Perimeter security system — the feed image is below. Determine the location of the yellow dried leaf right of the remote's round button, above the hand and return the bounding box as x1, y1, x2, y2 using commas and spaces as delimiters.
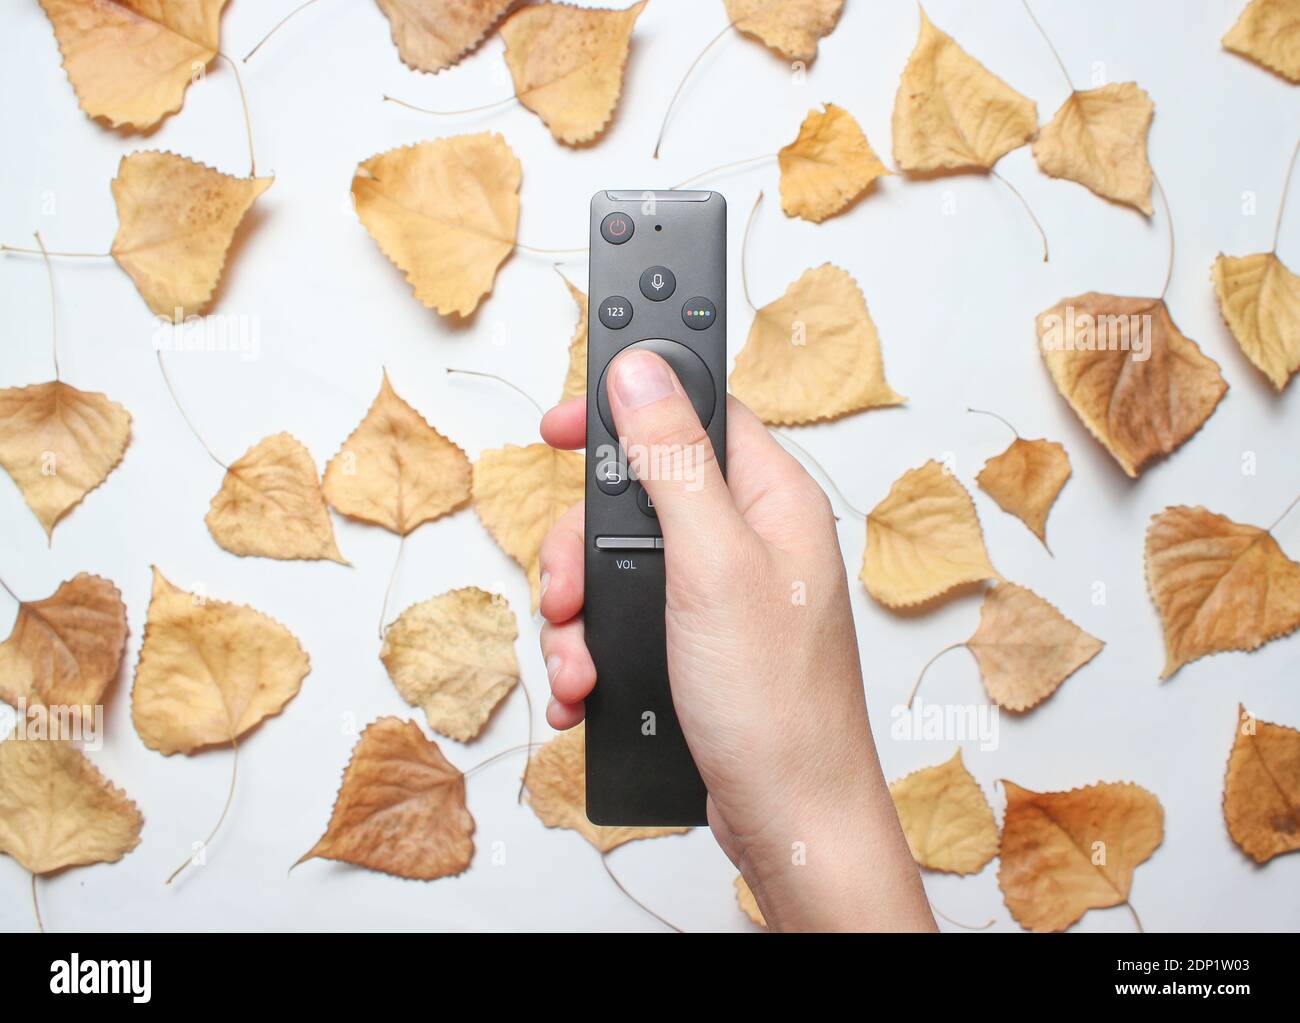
731, 263, 906, 425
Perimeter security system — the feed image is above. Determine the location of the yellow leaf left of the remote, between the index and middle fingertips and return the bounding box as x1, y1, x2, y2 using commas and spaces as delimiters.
473, 445, 585, 611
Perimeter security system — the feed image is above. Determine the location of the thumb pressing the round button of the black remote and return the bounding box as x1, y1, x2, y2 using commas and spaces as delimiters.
608, 348, 741, 550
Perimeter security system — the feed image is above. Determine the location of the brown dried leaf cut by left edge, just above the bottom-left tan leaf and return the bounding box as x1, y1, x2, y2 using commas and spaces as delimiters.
0, 572, 126, 707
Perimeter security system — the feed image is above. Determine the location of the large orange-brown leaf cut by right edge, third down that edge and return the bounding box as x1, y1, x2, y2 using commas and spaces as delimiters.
1147, 507, 1300, 679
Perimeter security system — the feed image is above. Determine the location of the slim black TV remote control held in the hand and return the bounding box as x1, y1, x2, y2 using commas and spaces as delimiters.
584, 191, 727, 827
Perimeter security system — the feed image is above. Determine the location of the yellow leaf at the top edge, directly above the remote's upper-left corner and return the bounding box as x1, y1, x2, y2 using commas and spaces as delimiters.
501, 0, 646, 146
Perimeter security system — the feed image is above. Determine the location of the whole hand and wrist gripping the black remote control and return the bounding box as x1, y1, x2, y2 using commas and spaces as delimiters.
541, 351, 935, 929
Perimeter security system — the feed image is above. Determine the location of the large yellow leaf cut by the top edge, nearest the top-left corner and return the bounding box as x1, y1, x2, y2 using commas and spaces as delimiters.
40, 0, 226, 129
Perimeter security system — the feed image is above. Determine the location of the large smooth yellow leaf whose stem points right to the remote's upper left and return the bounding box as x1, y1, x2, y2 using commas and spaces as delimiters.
352, 133, 521, 316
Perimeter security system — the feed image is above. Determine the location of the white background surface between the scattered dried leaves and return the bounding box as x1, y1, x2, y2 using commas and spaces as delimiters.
0, 0, 1300, 931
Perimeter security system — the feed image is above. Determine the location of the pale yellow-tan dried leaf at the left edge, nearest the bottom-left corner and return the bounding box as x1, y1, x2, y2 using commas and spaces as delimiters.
0, 737, 144, 874
